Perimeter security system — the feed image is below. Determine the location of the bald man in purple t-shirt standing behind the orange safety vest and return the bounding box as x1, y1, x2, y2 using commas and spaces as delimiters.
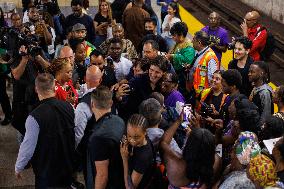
201, 12, 229, 62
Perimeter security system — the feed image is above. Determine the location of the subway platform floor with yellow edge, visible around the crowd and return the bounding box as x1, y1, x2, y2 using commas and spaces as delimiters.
0, 0, 284, 189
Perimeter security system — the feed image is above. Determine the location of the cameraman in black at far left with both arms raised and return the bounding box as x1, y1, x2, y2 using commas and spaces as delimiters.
11, 45, 49, 134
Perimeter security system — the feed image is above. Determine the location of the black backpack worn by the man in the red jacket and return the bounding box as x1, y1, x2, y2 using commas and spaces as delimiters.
256, 27, 275, 60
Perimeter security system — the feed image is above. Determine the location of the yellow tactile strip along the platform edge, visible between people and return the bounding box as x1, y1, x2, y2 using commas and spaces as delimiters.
179, 5, 277, 112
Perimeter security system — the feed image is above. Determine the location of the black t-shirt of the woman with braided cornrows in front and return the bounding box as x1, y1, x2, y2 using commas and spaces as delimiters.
128, 138, 154, 189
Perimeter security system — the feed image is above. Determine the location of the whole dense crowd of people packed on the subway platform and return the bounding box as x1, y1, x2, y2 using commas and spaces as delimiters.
0, 0, 284, 189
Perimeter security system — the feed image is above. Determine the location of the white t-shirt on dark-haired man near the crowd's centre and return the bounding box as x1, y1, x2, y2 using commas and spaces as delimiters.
113, 57, 132, 81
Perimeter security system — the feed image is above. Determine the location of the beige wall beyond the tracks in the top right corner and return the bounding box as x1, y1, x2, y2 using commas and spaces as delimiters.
241, 0, 284, 24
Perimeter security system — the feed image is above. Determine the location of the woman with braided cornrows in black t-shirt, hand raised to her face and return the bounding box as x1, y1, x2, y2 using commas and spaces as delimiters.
120, 114, 155, 189
